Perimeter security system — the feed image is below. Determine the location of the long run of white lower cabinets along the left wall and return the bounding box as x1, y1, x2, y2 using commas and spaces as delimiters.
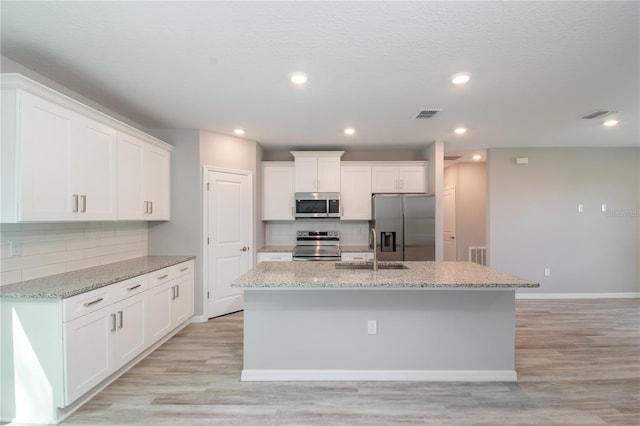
0, 260, 194, 424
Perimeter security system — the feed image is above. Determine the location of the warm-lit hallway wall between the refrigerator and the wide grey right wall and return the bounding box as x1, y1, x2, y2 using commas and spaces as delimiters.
444, 163, 487, 260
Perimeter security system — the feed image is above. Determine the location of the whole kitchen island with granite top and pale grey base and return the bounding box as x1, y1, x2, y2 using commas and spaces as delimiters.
232, 262, 539, 381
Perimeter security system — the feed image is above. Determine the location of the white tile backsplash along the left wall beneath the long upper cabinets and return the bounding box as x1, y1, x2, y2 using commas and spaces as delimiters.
0, 222, 148, 285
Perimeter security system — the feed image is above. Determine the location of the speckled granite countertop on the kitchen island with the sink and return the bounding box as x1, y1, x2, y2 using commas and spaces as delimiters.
231, 262, 540, 290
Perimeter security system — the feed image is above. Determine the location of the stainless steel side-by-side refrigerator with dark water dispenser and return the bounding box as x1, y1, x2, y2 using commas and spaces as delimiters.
371, 194, 436, 261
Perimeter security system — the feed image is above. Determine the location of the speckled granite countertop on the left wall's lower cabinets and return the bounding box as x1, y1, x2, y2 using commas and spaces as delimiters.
0, 256, 195, 299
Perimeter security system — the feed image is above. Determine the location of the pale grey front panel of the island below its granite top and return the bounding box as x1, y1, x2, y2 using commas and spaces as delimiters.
243, 288, 515, 380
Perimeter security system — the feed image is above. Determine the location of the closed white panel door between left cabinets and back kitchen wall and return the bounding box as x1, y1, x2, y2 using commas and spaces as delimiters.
205, 168, 253, 318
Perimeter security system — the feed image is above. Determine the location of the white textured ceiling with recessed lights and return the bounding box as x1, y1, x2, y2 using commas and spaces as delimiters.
0, 0, 640, 155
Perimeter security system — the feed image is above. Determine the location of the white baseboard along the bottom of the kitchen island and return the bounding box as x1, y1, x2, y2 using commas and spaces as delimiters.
240, 370, 518, 382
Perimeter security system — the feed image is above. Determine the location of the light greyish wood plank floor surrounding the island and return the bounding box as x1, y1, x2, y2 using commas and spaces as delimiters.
63, 299, 640, 425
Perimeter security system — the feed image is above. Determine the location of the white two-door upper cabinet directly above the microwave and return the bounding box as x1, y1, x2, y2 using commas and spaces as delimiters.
291, 151, 344, 192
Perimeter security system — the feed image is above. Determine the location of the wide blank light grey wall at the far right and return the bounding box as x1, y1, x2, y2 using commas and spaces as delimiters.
487, 148, 640, 293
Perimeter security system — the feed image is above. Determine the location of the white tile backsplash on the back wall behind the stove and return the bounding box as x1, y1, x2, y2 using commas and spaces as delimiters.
265, 219, 369, 246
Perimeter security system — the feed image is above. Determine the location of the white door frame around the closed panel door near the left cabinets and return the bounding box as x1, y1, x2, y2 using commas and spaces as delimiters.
202, 165, 256, 321
